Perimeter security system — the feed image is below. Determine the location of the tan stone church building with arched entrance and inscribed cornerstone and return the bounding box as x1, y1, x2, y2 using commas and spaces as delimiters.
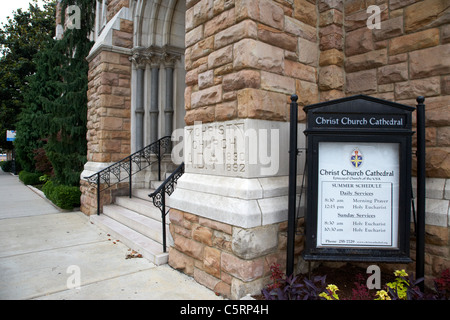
59, 0, 450, 299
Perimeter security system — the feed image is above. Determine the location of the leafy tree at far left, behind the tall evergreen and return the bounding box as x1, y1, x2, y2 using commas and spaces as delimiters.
0, 0, 56, 151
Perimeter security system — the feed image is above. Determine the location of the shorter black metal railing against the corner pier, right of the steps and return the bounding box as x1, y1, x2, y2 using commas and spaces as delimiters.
148, 162, 184, 252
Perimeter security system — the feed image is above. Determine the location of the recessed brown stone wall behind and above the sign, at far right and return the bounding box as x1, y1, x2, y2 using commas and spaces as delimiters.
344, 0, 450, 178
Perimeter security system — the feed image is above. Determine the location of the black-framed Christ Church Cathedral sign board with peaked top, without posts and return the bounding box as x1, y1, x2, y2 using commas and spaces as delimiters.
304, 95, 414, 262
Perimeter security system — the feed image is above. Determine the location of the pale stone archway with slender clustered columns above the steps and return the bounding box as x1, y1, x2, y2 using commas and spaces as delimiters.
131, 0, 186, 150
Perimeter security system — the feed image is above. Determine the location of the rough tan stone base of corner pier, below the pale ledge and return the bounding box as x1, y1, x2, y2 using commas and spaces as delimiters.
169, 209, 302, 299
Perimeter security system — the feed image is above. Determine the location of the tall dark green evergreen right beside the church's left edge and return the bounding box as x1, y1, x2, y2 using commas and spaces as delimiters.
16, 0, 95, 186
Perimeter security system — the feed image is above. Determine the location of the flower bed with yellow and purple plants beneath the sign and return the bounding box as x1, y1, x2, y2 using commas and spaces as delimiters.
255, 264, 450, 300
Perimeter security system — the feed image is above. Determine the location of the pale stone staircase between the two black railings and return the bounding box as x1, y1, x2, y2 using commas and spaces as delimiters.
90, 181, 173, 265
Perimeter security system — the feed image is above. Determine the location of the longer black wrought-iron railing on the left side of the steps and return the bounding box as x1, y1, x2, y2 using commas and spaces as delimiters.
85, 136, 172, 214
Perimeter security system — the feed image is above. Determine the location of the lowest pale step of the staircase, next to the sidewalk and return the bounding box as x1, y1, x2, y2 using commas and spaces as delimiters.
90, 214, 169, 265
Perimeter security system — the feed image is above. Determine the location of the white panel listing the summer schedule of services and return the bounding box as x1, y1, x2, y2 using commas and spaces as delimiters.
317, 142, 400, 248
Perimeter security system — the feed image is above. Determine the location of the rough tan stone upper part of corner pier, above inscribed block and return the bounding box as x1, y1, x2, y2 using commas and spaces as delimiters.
185, 0, 318, 125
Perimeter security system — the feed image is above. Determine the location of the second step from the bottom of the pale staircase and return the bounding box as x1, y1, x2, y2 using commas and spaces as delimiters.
103, 204, 173, 245
